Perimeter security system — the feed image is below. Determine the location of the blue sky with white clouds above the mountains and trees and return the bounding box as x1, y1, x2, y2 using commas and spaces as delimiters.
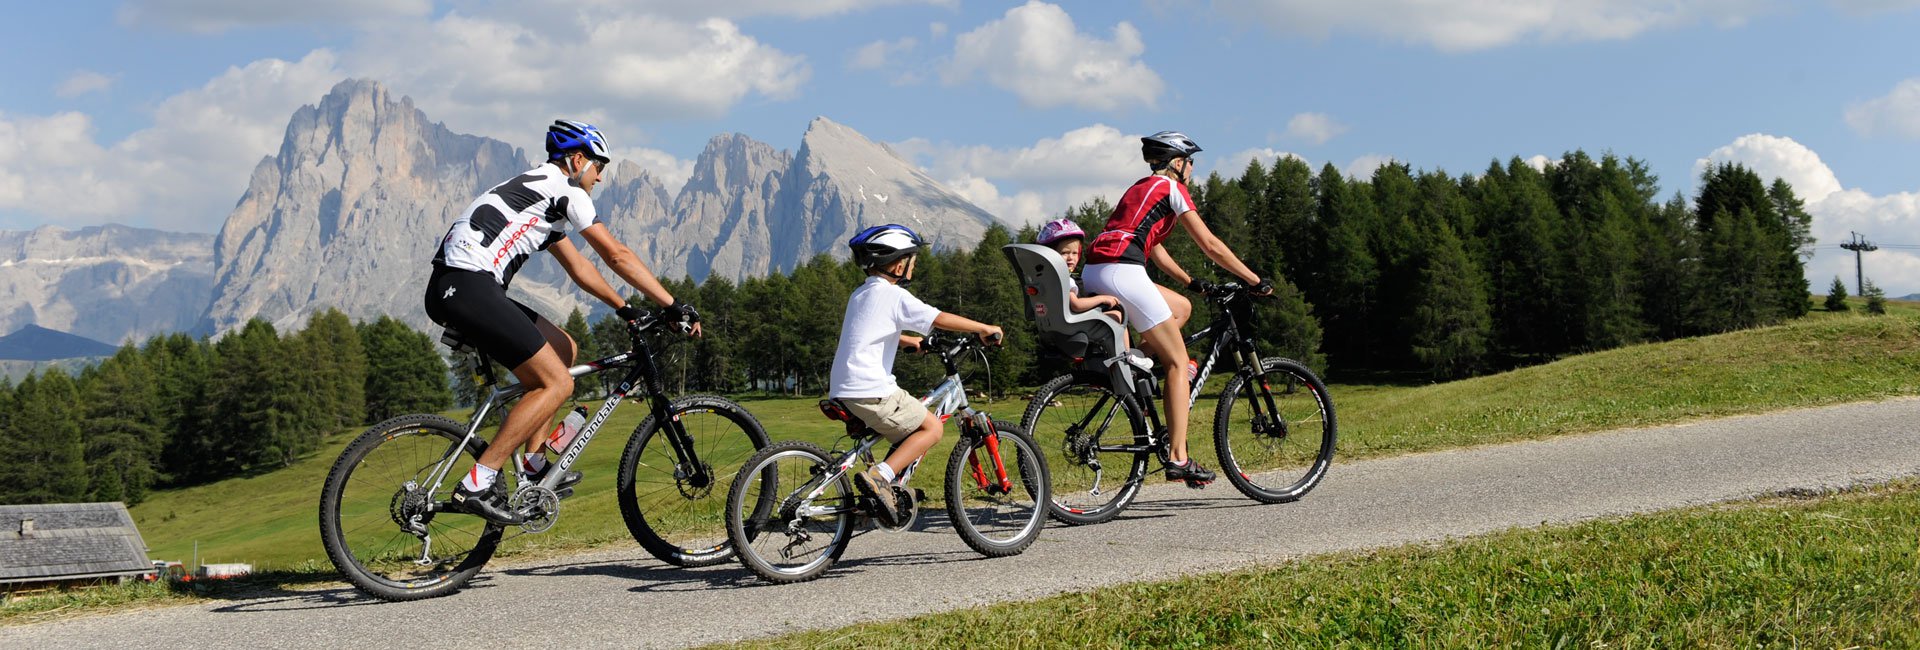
0, 0, 1920, 295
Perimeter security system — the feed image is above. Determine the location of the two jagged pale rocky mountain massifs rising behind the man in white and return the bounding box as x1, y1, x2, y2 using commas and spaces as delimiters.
194, 81, 995, 334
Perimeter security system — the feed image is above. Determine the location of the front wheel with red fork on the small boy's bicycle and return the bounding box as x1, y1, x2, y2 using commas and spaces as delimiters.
947, 422, 1048, 558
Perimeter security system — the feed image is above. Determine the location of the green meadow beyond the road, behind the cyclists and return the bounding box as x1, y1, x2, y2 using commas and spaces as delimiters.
132, 303, 1920, 569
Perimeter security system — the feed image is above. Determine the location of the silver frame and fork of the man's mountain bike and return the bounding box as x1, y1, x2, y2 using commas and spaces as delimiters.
426, 324, 714, 510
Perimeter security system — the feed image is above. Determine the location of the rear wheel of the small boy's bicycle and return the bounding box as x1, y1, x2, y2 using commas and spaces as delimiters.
726, 441, 854, 583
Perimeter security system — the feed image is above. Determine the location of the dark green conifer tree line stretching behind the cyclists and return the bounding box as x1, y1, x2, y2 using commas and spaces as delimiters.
0, 151, 1812, 502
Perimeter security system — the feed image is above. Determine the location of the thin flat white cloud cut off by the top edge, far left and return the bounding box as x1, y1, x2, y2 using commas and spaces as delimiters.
117, 0, 434, 33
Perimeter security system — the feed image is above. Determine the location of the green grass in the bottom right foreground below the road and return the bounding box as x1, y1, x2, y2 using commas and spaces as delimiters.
721, 481, 1920, 648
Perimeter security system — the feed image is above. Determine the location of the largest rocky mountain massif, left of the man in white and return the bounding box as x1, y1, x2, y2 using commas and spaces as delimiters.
205, 81, 530, 332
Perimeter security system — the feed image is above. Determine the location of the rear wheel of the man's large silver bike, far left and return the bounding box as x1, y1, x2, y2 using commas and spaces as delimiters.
321, 414, 501, 600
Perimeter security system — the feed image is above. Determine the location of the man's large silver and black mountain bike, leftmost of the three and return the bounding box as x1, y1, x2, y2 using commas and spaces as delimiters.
321, 314, 766, 600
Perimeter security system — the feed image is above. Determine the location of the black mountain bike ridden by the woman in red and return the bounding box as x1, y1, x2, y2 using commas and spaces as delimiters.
1008, 245, 1336, 523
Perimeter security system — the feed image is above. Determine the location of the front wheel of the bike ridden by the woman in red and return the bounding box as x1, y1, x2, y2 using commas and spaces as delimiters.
1213, 357, 1338, 502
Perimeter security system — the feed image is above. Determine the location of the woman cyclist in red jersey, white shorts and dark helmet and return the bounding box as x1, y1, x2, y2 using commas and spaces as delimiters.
1081, 130, 1273, 487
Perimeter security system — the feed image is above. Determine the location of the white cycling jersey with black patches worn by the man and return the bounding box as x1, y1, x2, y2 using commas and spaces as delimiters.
434, 163, 599, 286
